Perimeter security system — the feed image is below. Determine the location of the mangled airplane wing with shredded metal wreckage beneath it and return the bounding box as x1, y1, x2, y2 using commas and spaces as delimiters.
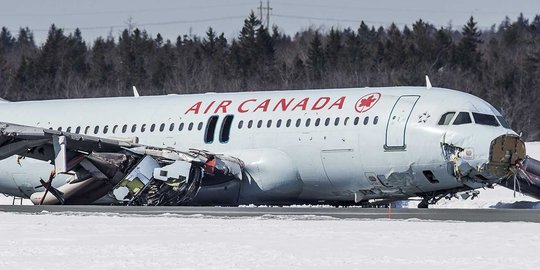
0, 122, 244, 205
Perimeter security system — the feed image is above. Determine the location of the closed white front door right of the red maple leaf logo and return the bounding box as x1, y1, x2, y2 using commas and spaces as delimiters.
384, 95, 420, 150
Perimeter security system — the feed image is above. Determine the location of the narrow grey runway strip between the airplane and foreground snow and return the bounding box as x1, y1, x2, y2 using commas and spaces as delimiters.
0, 205, 540, 223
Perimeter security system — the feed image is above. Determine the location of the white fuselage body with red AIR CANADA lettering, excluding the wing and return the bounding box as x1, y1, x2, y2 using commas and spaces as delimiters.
0, 87, 515, 204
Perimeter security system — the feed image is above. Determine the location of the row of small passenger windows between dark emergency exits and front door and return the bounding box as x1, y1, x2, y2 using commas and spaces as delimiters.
238, 116, 379, 129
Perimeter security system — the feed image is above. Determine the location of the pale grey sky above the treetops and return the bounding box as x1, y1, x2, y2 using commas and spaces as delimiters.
0, 0, 540, 43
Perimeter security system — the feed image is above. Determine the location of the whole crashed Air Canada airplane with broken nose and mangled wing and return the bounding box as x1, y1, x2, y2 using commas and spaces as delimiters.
0, 83, 540, 207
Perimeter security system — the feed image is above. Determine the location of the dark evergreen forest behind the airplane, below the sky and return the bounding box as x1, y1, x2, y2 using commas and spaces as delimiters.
0, 13, 540, 140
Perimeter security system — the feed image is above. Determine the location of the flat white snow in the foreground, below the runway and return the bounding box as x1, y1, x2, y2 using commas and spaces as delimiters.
0, 213, 540, 270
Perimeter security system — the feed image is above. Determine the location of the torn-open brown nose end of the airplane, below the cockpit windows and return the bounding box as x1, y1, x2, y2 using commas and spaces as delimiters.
486, 134, 525, 177
